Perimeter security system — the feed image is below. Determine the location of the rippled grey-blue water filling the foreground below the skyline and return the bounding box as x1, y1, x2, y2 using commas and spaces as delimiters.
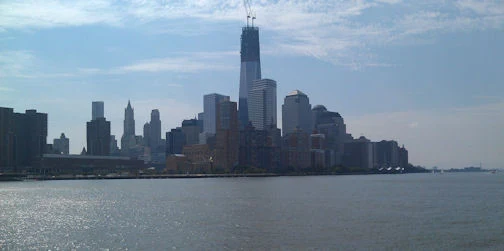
0, 173, 504, 250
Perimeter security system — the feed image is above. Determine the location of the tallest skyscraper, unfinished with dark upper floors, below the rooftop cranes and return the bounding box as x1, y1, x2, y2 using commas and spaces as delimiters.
239, 25, 261, 127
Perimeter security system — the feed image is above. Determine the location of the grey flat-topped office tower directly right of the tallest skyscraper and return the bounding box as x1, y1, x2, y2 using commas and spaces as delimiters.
248, 79, 277, 130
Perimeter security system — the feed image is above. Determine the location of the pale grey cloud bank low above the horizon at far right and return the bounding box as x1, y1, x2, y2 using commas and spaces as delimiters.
345, 102, 504, 168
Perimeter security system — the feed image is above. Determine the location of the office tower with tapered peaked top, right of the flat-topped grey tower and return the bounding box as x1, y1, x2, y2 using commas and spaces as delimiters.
282, 90, 312, 136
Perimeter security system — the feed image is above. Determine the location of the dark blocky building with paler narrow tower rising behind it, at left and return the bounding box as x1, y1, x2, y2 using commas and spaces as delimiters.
86, 118, 110, 156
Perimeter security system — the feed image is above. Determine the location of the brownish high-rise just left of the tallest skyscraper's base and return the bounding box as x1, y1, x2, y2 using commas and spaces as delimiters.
215, 101, 239, 170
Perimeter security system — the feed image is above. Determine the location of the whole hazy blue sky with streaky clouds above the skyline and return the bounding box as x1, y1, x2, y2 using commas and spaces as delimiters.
0, 0, 504, 168
